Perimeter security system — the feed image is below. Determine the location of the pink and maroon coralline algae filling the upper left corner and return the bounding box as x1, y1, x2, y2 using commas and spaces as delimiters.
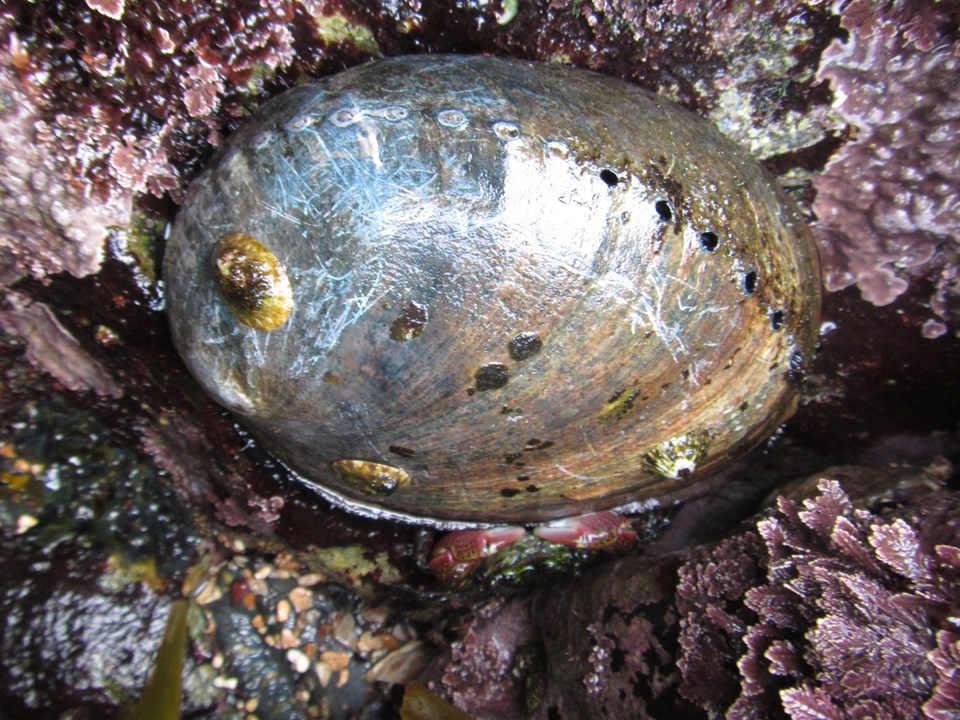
0, 0, 308, 284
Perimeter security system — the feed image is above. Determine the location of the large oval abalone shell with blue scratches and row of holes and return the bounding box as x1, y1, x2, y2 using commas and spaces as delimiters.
164, 56, 820, 525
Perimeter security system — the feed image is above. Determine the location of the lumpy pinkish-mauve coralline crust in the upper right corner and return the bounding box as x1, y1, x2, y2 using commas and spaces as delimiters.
813, 2, 960, 337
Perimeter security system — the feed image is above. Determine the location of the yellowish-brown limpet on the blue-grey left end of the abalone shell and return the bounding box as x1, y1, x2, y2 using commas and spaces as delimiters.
212, 233, 293, 330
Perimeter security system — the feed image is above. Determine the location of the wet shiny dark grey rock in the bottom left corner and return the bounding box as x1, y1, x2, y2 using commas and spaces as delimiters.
0, 537, 169, 718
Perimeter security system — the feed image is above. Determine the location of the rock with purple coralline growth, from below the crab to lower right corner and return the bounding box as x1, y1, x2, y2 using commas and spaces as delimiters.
438, 471, 960, 720
